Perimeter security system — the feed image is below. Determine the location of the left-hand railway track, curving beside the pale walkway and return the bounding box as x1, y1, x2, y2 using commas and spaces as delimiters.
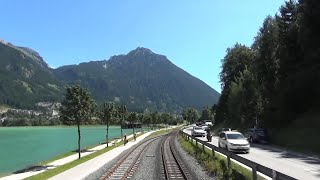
100, 137, 159, 180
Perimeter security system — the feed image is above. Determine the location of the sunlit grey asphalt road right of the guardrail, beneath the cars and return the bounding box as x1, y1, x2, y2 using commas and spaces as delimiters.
184, 128, 320, 180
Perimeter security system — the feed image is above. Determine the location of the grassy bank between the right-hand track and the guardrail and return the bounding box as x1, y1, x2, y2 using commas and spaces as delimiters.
178, 136, 264, 180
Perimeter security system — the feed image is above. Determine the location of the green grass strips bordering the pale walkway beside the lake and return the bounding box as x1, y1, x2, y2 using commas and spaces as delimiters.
26, 131, 142, 180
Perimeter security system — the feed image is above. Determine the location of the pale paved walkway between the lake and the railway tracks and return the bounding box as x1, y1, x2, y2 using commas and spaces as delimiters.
0, 131, 154, 180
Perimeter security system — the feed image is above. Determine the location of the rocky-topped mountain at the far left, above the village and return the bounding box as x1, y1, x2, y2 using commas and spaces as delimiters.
0, 41, 64, 108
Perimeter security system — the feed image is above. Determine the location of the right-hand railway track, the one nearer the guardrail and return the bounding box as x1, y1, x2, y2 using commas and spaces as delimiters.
161, 133, 191, 180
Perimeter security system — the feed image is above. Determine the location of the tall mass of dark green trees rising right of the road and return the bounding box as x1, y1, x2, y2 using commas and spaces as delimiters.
216, 0, 320, 155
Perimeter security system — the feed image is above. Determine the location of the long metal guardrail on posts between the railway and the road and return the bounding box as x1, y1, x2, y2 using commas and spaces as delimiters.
179, 130, 296, 180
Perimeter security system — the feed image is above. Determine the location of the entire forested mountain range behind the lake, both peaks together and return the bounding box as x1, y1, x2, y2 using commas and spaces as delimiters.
0, 42, 219, 112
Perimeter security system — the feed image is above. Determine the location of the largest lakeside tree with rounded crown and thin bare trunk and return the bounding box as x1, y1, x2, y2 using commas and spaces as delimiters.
60, 86, 96, 159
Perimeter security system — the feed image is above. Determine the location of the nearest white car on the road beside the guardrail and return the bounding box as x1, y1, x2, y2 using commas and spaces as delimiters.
218, 131, 250, 153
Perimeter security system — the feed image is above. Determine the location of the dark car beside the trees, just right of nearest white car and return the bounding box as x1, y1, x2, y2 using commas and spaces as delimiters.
244, 128, 269, 143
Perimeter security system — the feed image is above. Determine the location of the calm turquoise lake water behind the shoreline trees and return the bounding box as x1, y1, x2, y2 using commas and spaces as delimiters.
0, 126, 139, 174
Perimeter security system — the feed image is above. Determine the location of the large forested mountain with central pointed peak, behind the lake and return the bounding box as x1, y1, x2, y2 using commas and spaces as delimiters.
54, 48, 220, 112
